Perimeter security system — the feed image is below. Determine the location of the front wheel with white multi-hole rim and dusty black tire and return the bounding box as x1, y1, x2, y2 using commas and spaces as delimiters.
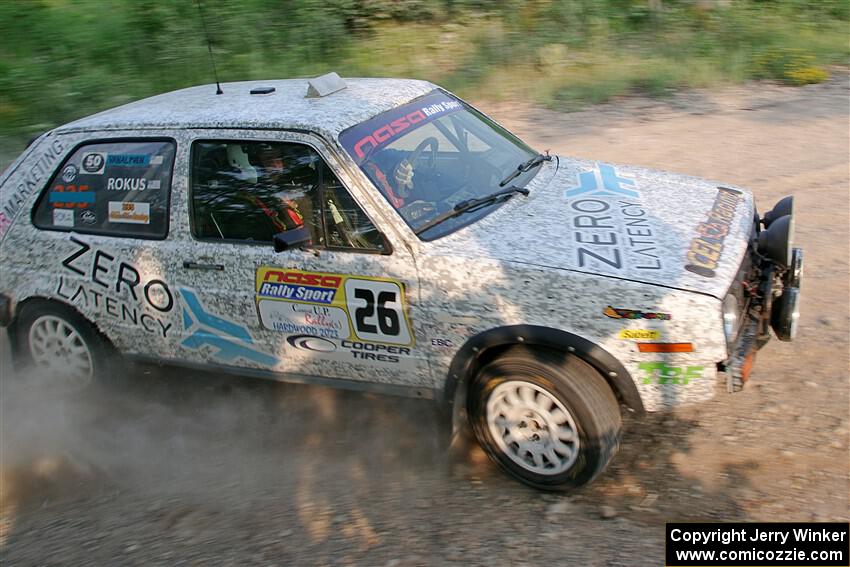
469, 347, 621, 490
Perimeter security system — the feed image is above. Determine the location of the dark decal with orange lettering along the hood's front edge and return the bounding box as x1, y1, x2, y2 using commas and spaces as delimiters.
685, 187, 742, 278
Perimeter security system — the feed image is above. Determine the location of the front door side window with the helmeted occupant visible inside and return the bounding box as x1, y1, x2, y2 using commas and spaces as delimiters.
191, 140, 385, 252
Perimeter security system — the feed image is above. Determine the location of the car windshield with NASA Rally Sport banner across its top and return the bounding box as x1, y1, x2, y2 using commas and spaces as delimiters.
339, 90, 539, 240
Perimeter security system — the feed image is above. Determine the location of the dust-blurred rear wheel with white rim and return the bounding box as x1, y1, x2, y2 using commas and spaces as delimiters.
16, 303, 110, 389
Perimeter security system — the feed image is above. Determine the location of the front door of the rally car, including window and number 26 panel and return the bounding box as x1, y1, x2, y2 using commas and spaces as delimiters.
172, 131, 430, 389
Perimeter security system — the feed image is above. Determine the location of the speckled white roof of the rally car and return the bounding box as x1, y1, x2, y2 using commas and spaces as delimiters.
56, 78, 436, 139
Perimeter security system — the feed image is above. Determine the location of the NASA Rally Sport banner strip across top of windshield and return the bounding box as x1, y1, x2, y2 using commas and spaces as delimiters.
339, 91, 463, 165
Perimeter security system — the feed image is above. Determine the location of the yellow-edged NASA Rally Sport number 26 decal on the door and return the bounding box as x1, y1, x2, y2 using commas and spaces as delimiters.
256, 267, 414, 345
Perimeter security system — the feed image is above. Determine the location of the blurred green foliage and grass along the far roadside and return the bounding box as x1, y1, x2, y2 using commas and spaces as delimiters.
0, 0, 850, 145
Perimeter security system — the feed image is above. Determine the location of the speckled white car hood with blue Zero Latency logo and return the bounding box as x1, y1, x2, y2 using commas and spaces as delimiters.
430, 156, 754, 298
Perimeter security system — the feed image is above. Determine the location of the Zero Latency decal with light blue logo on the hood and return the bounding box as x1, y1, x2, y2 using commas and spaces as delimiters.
564, 163, 662, 271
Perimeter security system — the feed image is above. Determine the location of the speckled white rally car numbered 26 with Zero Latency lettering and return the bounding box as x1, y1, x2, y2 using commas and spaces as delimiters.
0, 74, 802, 489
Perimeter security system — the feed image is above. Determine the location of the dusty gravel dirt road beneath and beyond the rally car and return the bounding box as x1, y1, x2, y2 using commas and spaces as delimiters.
0, 73, 850, 566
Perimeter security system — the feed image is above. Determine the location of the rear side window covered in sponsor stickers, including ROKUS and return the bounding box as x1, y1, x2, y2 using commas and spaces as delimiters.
33, 140, 174, 242
